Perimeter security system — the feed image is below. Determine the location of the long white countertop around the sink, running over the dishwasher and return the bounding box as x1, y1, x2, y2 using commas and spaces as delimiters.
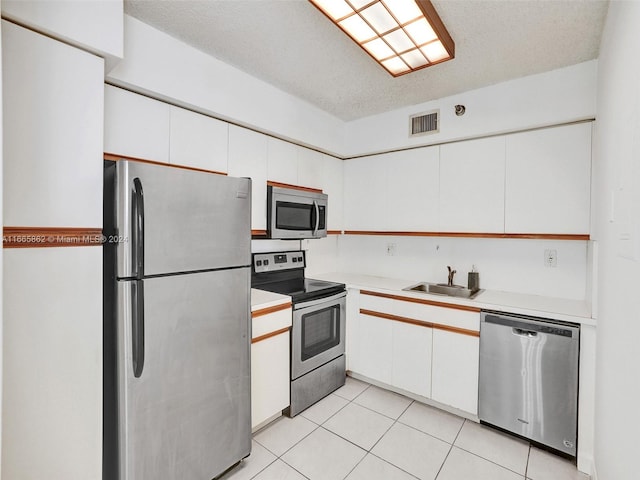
313, 272, 596, 326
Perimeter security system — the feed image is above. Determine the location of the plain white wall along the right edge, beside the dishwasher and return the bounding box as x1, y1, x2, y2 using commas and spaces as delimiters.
594, 1, 640, 480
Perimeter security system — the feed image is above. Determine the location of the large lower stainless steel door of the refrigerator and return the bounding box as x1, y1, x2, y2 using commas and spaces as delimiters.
117, 268, 251, 480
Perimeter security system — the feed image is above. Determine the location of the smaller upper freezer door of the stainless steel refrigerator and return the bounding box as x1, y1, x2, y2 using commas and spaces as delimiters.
114, 160, 251, 278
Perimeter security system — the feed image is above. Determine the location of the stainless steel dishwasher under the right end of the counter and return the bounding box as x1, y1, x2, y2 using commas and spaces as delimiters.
478, 312, 580, 457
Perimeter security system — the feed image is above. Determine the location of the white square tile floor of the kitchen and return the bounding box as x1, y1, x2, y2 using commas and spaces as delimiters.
223, 377, 589, 480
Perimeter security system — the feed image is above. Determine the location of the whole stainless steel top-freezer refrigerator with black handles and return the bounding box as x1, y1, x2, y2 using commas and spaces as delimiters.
103, 160, 251, 480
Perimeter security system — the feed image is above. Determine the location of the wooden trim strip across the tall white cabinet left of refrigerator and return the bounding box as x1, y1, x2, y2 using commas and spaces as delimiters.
2, 226, 102, 248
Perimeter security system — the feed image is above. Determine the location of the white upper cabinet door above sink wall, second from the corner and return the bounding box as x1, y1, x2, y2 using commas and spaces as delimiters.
382, 147, 440, 232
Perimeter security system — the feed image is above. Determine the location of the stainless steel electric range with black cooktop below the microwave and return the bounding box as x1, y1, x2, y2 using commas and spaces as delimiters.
251, 250, 347, 417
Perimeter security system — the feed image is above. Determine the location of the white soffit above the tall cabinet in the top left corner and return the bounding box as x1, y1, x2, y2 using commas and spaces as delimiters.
2, 0, 124, 62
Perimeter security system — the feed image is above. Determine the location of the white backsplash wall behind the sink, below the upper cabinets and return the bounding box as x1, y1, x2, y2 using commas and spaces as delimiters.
303, 235, 590, 300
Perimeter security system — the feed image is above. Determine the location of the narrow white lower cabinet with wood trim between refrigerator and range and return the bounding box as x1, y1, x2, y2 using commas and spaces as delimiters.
251, 306, 292, 430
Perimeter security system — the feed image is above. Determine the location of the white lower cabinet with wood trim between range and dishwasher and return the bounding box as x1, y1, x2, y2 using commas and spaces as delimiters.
347, 290, 480, 416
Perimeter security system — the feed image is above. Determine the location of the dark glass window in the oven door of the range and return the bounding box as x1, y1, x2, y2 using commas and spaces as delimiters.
302, 305, 340, 361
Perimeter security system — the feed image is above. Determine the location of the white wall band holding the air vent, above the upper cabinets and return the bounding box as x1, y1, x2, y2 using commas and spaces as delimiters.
343, 60, 597, 157
